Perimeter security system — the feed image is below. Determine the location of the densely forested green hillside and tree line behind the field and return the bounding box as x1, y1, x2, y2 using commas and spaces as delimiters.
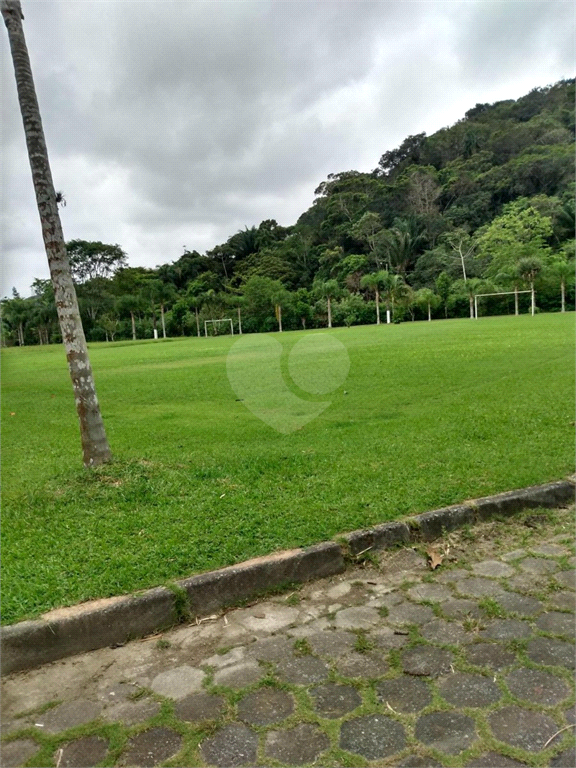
2, 80, 574, 344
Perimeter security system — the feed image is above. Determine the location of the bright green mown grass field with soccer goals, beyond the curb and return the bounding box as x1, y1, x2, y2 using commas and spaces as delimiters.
2, 313, 574, 623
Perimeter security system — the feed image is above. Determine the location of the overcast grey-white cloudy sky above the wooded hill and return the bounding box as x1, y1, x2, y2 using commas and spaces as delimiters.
1, 0, 574, 295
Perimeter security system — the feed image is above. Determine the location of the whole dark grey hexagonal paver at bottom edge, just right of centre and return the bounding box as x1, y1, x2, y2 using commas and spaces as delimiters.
340, 715, 406, 760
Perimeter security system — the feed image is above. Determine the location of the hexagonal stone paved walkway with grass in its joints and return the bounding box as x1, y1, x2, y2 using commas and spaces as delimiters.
2, 509, 576, 768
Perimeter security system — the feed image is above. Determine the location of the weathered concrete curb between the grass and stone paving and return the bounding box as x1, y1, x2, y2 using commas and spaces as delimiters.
0, 480, 575, 675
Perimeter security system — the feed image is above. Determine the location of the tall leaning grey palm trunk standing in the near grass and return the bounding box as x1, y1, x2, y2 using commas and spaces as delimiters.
1, 0, 112, 466
